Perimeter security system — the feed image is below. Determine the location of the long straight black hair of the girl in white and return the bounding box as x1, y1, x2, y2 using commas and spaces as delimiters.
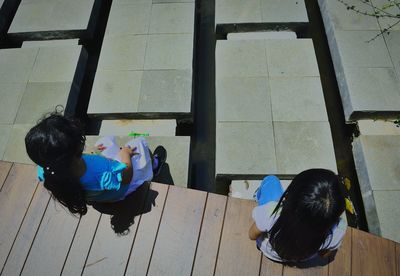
269, 169, 345, 262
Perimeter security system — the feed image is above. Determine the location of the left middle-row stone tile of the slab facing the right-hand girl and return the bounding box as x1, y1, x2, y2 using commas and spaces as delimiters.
216, 77, 272, 122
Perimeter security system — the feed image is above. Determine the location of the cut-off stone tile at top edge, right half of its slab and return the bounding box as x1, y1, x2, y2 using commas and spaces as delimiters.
261, 0, 308, 22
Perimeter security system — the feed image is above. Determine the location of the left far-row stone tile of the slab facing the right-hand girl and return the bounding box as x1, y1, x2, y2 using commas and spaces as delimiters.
215, 40, 268, 79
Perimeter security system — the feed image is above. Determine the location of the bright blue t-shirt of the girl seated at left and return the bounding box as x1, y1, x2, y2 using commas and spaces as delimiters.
38, 154, 129, 202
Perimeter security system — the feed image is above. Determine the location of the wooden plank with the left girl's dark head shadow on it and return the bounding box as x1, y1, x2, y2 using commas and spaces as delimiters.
83, 182, 148, 275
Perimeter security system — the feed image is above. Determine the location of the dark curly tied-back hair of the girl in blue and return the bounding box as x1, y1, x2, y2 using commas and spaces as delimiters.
25, 111, 87, 216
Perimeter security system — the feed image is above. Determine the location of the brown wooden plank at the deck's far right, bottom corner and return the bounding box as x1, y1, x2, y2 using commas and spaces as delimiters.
352, 229, 396, 276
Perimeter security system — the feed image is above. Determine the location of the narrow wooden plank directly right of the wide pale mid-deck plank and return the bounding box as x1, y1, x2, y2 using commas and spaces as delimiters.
192, 194, 227, 276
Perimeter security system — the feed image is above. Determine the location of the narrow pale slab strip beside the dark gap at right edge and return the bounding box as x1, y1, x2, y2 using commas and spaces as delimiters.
357, 120, 400, 135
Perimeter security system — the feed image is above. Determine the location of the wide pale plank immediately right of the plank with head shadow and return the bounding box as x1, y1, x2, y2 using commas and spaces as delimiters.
148, 186, 207, 276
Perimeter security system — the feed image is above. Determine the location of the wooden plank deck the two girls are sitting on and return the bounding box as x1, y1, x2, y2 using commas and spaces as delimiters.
0, 162, 400, 276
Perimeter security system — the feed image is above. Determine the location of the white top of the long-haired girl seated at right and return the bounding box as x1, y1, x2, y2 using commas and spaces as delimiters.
252, 201, 347, 262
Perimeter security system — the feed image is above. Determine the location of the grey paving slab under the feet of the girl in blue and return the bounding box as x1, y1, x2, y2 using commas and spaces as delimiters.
86, 136, 190, 187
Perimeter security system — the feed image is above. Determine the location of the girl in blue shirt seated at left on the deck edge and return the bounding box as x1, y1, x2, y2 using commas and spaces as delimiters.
25, 113, 165, 216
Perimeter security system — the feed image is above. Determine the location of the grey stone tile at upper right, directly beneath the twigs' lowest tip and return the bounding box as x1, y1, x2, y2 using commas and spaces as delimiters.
335, 31, 393, 67
